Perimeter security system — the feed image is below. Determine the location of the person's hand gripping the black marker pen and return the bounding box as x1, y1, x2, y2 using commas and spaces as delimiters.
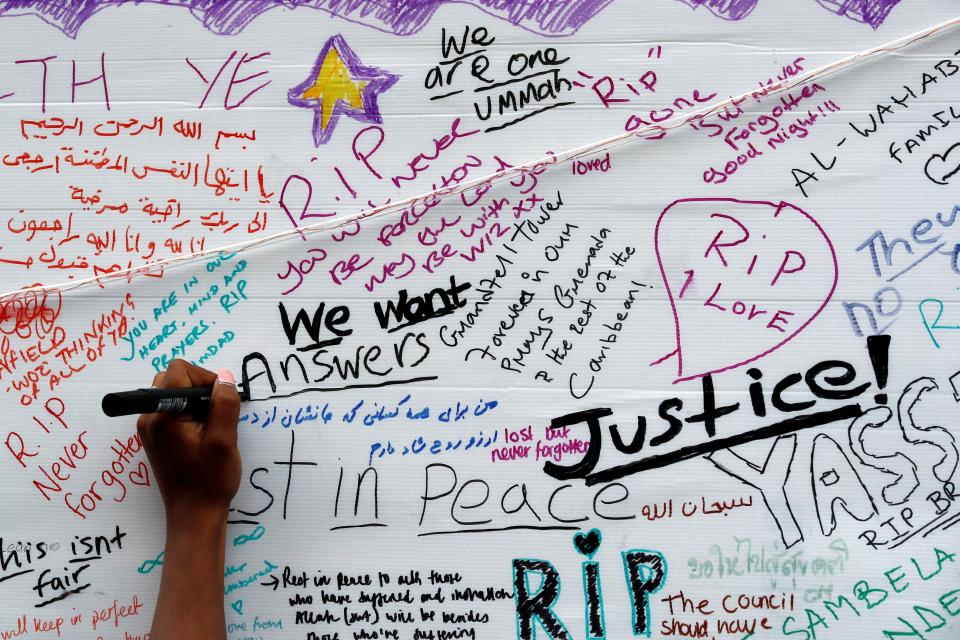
137, 359, 241, 528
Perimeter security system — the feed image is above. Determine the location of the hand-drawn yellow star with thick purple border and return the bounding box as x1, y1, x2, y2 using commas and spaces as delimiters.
287, 34, 400, 147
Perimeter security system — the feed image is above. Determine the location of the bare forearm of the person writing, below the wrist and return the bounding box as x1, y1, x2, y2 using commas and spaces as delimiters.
151, 511, 227, 640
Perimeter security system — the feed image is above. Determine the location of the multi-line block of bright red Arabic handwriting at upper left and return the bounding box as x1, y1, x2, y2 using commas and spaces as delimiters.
0, 116, 274, 280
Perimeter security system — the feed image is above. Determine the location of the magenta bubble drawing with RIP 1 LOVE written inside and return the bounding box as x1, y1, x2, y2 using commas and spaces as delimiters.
651, 198, 839, 383
